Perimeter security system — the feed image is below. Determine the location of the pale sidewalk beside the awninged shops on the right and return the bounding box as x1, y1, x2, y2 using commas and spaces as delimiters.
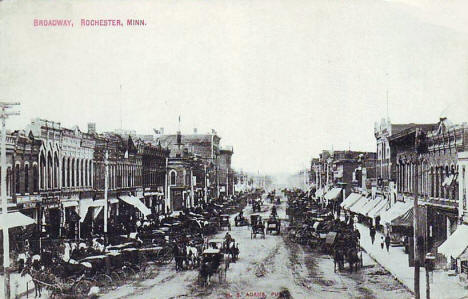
356, 223, 468, 299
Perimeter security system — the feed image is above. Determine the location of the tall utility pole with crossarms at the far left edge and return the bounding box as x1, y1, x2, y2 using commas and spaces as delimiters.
0, 102, 20, 299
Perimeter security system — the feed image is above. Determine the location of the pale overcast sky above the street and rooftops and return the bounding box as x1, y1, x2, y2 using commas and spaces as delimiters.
0, 0, 468, 173
